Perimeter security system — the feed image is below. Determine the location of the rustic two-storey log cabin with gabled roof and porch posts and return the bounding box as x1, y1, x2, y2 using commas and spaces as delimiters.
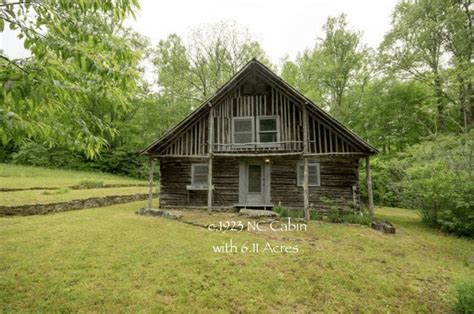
142, 59, 377, 219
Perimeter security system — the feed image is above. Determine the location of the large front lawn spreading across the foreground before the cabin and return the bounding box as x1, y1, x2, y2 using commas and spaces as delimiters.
0, 202, 474, 312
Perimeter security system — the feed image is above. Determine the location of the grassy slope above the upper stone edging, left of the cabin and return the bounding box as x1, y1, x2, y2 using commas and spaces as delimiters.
0, 163, 146, 188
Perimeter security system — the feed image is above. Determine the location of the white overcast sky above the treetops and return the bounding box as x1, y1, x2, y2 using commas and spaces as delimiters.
0, 0, 396, 65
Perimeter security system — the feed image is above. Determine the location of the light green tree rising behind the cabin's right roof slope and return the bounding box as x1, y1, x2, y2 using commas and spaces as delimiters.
282, 14, 369, 121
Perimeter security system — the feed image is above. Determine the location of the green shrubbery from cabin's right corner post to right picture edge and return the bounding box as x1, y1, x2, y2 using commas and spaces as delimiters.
361, 131, 474, 237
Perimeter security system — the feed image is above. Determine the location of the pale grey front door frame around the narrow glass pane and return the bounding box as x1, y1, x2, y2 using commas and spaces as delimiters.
239, 158, 271, 206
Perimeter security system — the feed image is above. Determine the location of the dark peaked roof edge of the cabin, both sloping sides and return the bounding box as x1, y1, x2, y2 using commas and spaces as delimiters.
141, 58, 378, 155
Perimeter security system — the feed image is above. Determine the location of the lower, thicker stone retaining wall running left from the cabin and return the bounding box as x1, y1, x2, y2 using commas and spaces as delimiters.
0, 193, 158, 216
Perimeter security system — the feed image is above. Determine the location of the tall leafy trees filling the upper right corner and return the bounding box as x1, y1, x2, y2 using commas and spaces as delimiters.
380, 0, 474, 132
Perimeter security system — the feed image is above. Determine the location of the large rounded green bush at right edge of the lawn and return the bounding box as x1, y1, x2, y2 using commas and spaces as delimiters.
402, 132, 474, 237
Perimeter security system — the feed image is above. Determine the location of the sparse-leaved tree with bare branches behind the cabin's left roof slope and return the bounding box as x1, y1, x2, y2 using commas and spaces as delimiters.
153, 22, 270, 106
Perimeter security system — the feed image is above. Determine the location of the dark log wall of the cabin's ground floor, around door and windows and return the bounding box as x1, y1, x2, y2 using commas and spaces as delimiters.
160, 156, 360, 209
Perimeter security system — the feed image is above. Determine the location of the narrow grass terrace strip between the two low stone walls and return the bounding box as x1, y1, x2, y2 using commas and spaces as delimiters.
0, 186, 148, 206
